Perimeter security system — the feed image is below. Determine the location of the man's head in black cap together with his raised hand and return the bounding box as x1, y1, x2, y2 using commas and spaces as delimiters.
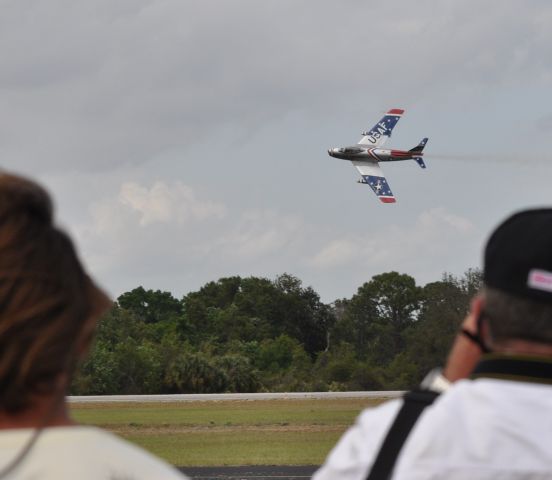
445, 208, 552, 381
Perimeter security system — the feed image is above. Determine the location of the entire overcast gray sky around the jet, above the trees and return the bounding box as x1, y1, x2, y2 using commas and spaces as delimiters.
0, 0, 552, 302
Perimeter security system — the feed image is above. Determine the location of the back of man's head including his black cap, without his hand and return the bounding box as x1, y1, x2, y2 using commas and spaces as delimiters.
481, 209, 552, 348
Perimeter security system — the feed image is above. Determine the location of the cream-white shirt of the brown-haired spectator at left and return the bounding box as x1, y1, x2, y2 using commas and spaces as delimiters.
0, 426, 187, 480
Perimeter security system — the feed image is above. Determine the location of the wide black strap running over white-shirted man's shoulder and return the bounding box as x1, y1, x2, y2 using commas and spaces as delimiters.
366, 390, 439, 480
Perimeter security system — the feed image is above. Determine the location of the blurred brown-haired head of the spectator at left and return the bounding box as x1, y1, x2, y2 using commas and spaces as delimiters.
0, 172, 110, 415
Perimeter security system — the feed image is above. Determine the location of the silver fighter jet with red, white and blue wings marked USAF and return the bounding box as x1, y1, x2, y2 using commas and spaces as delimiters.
328, 108, 427, 203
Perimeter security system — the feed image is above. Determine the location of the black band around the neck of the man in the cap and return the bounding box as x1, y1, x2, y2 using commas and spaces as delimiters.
471, 353, 552, 385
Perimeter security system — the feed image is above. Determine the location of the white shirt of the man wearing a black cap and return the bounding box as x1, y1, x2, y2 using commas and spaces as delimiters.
313, 378, 552, 480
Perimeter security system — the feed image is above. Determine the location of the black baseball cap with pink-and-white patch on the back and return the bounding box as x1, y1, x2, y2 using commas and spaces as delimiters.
483, 208, 552, 303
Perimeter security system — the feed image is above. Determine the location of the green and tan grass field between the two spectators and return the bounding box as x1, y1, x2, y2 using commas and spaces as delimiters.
71, 399, 388, 467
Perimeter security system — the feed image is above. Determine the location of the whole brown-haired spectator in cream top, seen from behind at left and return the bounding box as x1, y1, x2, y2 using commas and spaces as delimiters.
0, 172, 186, 480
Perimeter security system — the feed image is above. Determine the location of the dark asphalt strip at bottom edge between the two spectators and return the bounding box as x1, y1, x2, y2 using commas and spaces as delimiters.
179, 465, 318, 480
